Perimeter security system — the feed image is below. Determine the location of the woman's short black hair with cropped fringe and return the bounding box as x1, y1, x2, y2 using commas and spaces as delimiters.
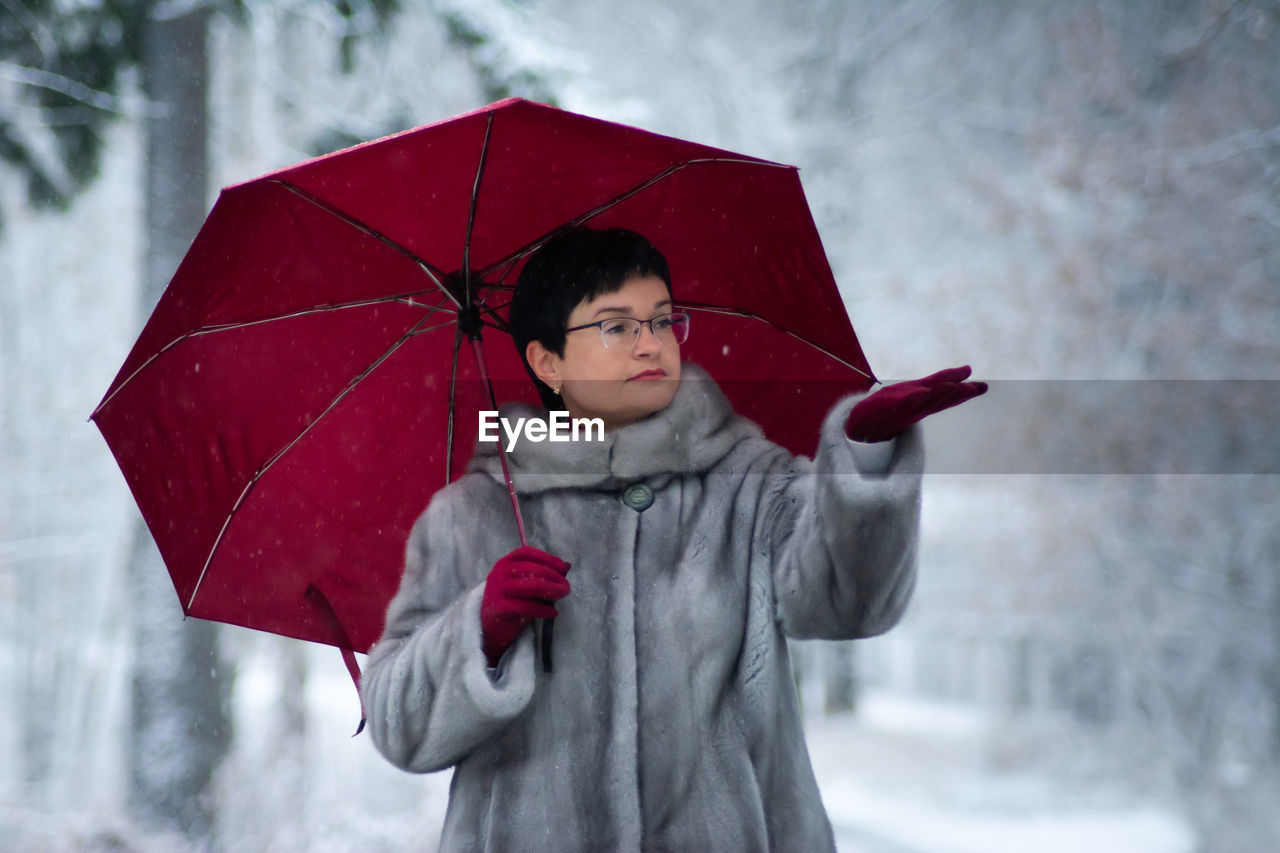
507, 225, 671, 409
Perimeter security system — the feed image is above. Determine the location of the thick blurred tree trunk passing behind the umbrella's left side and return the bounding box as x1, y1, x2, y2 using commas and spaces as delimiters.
129, 4, 230, 843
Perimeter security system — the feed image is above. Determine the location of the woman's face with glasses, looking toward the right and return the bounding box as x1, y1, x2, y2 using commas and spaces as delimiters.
526, 275, 680, 429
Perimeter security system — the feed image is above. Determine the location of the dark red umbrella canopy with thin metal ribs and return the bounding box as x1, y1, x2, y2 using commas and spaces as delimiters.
93, 100, 873, 652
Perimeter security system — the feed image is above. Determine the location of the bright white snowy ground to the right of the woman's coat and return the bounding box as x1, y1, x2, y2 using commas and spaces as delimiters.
808, 694, 1197, 853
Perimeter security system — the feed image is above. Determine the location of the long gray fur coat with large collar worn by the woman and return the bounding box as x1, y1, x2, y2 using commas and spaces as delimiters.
362, 364, 923, 853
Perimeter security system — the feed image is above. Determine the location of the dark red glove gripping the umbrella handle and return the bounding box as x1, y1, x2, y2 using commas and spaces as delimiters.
480, 546, 568, 666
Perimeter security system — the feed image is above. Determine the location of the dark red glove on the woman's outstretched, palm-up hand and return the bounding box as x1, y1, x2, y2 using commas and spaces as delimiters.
845, 365, 987, 442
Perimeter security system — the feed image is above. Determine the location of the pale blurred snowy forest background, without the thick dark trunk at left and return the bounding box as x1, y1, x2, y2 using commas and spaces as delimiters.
0, 0, 1280, 853
